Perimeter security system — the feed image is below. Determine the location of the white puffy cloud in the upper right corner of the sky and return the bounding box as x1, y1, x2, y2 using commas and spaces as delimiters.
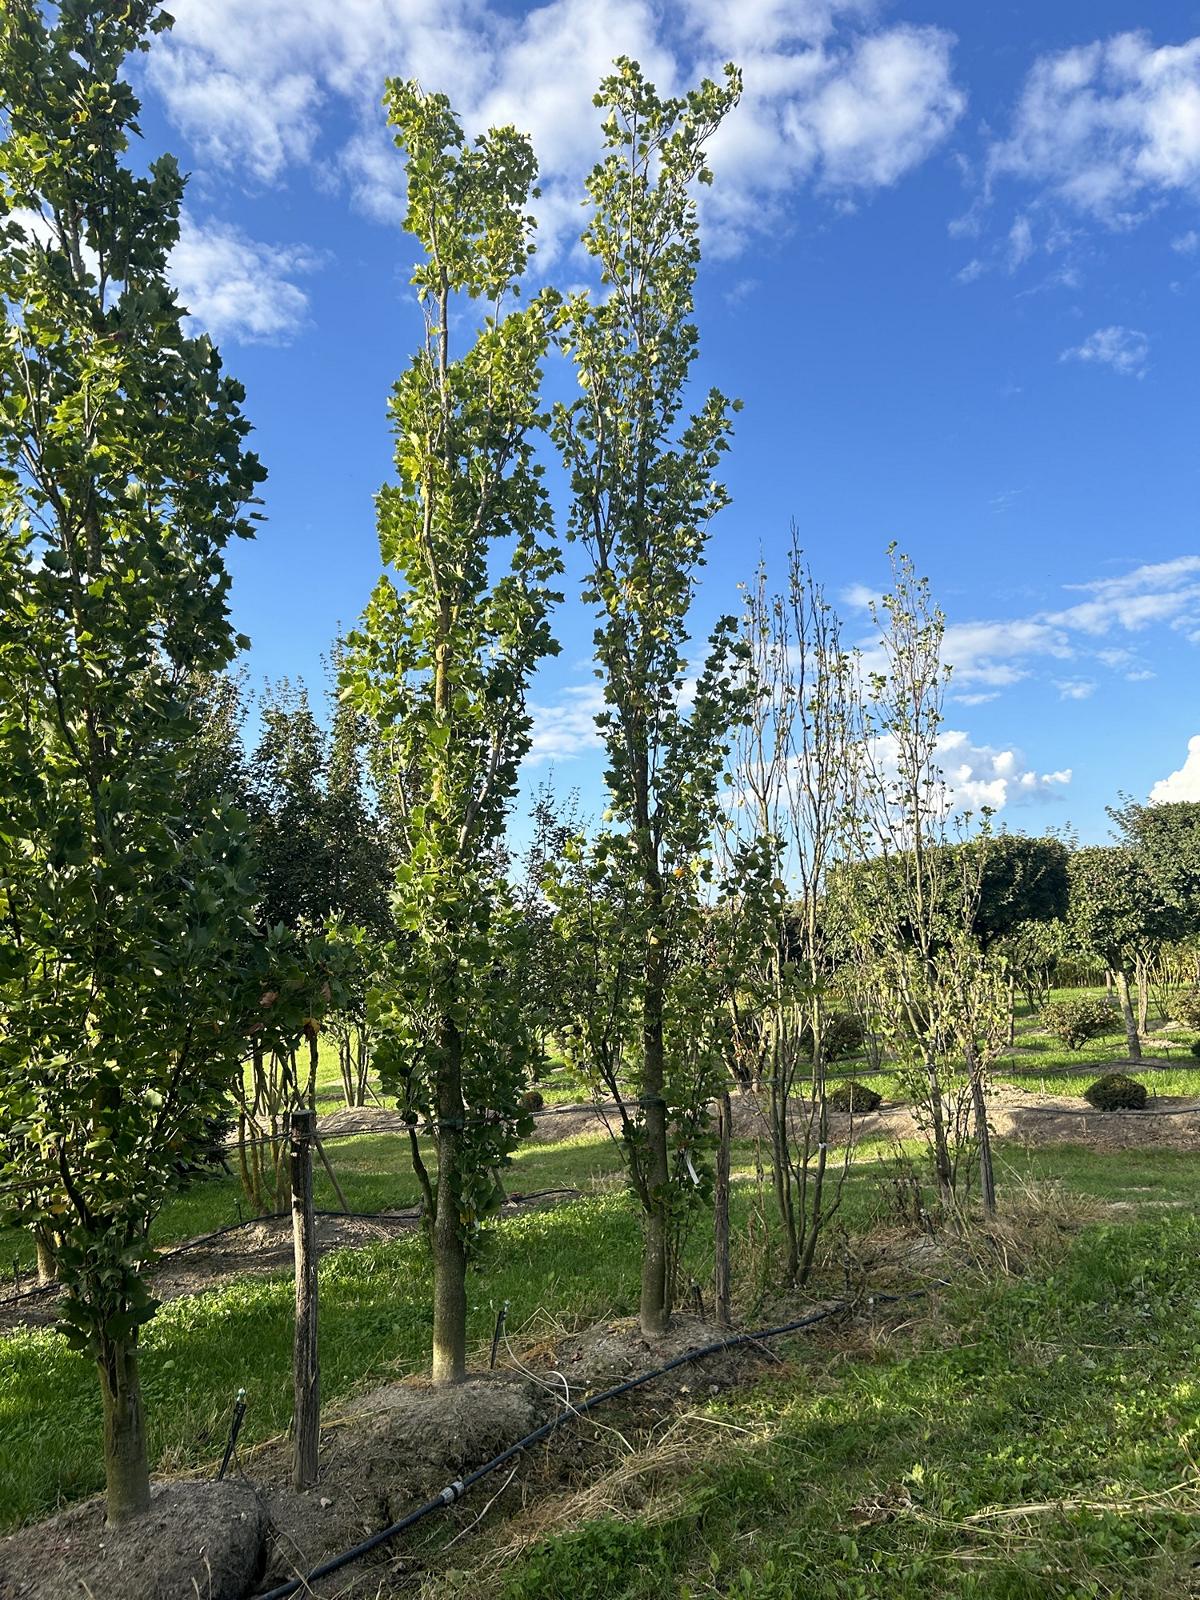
989, 34, 1200, 227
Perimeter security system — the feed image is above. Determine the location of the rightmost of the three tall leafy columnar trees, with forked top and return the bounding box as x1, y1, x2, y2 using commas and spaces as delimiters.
552, 58, 739, 1334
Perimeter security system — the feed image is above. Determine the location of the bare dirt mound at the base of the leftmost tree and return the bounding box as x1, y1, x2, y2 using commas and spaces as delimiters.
0, 1482, 267, 1600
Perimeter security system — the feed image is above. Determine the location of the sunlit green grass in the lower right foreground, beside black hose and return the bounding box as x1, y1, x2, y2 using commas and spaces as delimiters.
486, 1214, 1200, 1600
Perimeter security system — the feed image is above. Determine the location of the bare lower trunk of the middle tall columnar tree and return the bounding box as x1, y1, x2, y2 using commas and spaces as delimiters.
432, 1021, 467, 1384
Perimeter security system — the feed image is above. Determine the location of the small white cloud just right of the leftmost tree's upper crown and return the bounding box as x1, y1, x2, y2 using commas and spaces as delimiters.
170, 214, 320, 344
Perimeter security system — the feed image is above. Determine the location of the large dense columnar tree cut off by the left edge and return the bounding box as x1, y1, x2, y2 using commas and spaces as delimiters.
0, 0, 262, 1522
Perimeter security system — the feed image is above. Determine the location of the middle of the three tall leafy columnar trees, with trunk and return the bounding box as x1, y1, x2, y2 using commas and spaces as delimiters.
347, 82, 560, 1382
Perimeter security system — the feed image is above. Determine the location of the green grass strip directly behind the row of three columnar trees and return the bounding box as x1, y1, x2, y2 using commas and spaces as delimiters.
0, 1177, 764, 1526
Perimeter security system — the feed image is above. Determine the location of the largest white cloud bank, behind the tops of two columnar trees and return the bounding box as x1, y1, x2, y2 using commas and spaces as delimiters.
147, 0, 966, 253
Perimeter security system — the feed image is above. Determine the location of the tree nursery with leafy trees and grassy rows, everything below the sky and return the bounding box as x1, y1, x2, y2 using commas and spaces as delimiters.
0, 0, 1200, 1600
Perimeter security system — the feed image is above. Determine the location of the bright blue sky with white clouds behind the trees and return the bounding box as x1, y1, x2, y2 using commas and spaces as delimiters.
124, 0, 1200, 838
